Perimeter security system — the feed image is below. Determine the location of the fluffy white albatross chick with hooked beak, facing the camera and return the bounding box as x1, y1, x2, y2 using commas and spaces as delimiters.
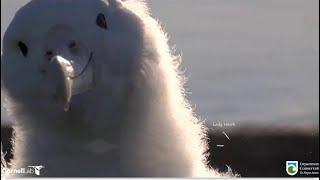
1, 0, 232, 177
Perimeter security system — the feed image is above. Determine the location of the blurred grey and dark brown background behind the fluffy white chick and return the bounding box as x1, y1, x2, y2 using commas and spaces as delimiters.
1, 0, 319, 177
